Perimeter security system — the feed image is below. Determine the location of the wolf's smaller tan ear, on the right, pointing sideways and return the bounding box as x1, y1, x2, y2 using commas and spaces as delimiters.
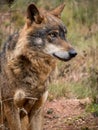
50, 3, 65, 18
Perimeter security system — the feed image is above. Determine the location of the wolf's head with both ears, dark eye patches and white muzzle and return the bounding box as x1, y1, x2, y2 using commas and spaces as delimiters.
16, 4, 77, 61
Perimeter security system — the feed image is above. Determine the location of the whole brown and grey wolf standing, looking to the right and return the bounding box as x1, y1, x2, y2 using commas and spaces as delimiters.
0, 3, 77, 130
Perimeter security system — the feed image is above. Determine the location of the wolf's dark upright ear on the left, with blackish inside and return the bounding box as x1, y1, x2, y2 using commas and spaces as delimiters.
27, 4, 43, 26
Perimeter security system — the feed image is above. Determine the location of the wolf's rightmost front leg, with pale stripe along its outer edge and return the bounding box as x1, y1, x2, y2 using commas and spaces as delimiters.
28, 91, 48, 130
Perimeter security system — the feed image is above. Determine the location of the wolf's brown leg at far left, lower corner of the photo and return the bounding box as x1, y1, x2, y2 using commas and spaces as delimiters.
4, 101, 21, 130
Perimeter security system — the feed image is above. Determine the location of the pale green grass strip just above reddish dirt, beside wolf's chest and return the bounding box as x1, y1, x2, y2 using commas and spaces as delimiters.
49, 81, 91, 99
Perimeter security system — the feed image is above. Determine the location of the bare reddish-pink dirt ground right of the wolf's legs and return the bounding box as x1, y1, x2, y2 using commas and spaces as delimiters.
44, 98, 98, 130
